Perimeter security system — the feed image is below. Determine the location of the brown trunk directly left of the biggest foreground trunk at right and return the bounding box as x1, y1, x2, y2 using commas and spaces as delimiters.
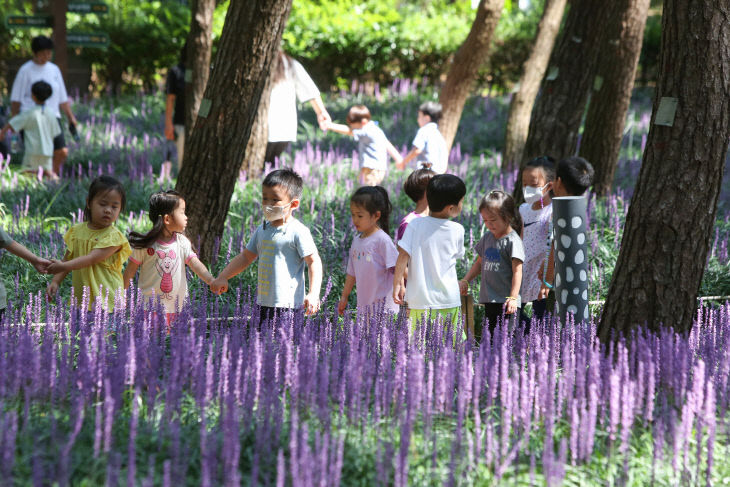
580, 0, 649, 196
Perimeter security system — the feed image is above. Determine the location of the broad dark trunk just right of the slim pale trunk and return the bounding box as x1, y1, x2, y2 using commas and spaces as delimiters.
514, 0, 611, 201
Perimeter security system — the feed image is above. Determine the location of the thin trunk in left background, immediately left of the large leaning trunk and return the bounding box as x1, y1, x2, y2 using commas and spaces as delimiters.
180, 0, 215, 164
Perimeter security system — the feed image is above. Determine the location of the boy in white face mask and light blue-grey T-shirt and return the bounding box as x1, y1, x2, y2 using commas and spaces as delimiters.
210, 169, 322, 323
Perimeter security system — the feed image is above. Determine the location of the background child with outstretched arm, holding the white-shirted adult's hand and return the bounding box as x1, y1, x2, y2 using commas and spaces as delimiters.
327, 105, 403, 186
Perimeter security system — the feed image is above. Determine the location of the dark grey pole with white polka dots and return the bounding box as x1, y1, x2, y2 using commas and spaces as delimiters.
553, 196, 589, 323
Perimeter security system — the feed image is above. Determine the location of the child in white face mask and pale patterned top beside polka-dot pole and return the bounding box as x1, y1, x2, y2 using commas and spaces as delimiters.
520, 156, 555, 332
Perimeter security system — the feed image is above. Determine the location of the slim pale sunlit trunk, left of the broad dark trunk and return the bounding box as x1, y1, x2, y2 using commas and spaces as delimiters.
502, 0, 566, 169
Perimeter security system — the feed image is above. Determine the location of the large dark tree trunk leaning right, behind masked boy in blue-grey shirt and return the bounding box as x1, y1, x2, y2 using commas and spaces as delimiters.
177, 0, 291, 261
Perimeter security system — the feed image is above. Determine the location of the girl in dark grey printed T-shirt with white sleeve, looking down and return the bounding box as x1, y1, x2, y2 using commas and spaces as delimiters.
459, 191, 525, 342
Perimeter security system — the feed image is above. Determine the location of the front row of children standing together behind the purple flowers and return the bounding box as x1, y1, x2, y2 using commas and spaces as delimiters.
0, 149, 593, 340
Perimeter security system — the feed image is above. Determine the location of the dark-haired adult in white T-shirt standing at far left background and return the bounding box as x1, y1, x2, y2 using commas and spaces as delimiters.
10, 36, 77, 175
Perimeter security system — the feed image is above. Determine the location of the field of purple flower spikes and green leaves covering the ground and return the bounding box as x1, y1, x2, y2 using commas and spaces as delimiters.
0, 81, 730, 486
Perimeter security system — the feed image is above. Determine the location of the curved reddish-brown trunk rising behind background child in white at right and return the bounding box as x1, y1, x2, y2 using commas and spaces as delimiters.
439, 0, 504, 151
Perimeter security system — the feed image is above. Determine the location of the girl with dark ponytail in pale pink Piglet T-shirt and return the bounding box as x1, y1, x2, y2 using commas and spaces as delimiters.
124, 191, 213, 325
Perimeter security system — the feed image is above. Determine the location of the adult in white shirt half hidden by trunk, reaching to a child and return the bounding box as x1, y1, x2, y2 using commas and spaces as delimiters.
264, 50, 332, 162
